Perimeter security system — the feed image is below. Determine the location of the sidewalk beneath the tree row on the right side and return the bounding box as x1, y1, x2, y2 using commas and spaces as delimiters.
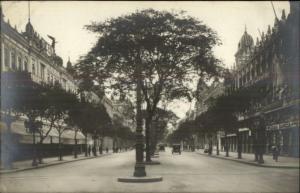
196, 149, 299, 169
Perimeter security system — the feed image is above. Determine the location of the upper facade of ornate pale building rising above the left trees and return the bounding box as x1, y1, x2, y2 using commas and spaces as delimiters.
1, 15, 77, 92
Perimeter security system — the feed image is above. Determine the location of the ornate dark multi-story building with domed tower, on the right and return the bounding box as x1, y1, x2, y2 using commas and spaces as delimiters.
225, 2, 300, 156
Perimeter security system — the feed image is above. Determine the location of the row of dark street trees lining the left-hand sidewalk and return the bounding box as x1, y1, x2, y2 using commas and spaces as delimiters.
1, 72, 132, 168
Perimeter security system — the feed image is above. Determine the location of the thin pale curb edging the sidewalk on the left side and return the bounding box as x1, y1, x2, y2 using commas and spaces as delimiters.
0, 153, 112, 175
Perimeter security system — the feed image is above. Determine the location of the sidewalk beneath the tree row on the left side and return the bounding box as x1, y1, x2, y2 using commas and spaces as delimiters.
0, 153, 112, 174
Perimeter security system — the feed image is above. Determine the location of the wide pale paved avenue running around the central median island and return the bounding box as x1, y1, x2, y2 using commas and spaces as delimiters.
0, 149, 299, 193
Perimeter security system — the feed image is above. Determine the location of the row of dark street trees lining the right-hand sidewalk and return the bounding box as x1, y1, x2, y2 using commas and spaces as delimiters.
170, 74, 269, 162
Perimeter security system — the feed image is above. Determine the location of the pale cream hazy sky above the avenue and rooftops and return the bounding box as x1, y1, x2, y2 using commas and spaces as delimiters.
2, 1, 289, 118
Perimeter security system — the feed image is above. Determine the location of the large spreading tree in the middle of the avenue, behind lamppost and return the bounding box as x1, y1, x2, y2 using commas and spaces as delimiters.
77, 9, 220, 161
